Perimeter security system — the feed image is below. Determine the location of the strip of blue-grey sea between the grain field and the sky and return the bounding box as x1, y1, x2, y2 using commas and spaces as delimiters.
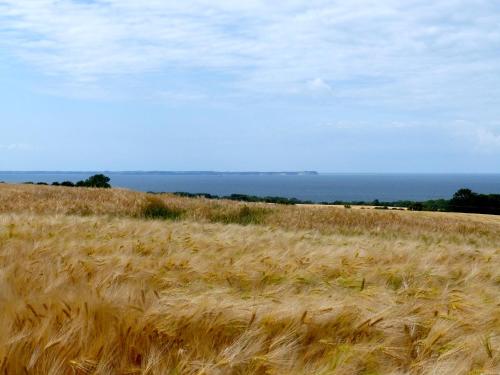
0, 172, 500, 202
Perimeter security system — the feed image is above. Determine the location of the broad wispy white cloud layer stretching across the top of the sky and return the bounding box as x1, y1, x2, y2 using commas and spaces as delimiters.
0, 0, 500, 106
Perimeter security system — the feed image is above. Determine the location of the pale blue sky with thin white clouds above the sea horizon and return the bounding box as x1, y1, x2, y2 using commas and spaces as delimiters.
0, 0, 500, 173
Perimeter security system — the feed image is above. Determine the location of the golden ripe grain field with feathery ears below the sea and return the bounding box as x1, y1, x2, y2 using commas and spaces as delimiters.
0, 184, 500, 375
